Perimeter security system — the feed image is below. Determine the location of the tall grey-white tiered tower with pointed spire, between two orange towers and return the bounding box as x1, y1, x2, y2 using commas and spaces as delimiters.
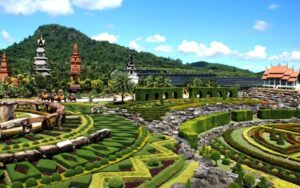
33, 36, 51, 77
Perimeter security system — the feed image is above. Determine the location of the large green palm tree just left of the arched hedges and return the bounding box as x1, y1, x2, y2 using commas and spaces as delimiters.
113, 72, 133, 103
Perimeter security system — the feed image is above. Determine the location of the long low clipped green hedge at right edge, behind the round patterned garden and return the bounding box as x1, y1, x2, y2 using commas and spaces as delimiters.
257, 109, 300, 119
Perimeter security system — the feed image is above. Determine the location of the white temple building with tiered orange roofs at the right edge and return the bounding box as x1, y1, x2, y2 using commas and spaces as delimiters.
262, 65, 300, 89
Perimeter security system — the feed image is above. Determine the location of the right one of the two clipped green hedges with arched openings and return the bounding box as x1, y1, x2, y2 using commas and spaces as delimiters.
188, 87, 238, 98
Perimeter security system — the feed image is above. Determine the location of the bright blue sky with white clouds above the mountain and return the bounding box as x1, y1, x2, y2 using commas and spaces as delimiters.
0, 0, 300, 71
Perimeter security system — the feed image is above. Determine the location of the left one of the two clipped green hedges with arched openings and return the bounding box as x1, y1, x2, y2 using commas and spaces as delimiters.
135, 87, 183, 101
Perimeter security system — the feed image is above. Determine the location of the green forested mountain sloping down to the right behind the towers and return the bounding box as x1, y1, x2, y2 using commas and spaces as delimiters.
1, 24, 256, 79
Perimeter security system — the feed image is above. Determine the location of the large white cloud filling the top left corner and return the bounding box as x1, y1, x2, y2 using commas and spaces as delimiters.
0, 0, 73, 16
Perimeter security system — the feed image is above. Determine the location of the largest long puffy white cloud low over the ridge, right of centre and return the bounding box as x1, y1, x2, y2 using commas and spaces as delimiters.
178, 40, 232, 57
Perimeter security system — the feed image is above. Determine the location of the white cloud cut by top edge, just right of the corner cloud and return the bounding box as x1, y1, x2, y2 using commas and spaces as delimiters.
72, 0, 123, 10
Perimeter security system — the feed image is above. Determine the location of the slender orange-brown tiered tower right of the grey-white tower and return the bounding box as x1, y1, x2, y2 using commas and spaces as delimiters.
70, 43, 81, 91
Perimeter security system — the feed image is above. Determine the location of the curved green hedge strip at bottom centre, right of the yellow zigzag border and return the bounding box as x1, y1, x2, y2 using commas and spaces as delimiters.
140, 157, 184, 188
